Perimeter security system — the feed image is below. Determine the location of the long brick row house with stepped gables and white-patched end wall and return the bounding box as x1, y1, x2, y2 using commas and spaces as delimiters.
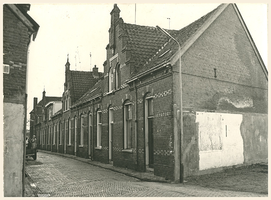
29, 4, 268, 182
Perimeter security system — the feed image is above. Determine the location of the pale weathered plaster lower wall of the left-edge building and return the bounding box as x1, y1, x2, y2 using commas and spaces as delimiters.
4, 103, 25, 197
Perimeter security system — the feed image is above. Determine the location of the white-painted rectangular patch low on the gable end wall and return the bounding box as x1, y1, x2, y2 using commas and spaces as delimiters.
196, 112, 244, 170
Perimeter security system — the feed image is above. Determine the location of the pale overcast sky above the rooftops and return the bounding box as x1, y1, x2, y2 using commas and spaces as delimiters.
27, 3, 267, 124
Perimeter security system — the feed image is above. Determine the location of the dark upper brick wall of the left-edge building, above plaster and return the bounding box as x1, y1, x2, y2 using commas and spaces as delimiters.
3, 5, 30, 104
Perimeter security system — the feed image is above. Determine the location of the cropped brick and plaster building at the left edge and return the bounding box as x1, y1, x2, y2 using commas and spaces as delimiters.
3, 4, 39, 197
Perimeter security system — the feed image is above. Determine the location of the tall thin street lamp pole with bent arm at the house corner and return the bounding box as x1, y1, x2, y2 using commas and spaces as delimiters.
156, 26, 184, 183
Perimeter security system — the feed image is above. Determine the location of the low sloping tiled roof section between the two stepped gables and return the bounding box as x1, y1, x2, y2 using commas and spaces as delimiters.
72, 80, 103, 107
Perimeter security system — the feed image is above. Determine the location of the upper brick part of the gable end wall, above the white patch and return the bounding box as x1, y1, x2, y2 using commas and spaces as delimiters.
182, 6, 268, 113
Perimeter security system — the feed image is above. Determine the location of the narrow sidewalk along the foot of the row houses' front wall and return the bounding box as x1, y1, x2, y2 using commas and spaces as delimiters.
37, 150, 170, 183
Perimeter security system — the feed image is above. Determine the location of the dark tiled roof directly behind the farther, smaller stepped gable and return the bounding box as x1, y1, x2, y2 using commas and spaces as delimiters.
70, 71, 97, 102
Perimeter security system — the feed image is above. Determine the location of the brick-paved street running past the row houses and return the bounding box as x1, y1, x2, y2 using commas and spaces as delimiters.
26, 152, 267, 197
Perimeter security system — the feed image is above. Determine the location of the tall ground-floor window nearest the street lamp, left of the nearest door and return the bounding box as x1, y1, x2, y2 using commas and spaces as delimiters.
124, 103, 132, 149
